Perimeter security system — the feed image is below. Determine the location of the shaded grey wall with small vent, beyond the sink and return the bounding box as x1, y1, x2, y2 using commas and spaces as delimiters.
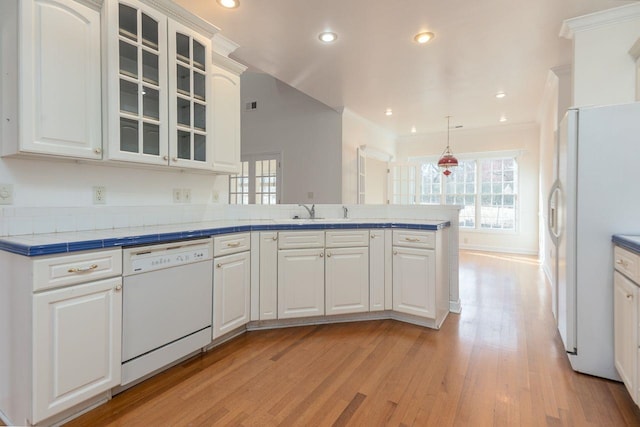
241, 72, 342, 203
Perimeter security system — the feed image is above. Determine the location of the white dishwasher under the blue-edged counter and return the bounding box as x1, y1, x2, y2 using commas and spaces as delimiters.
121, 238, 213, 385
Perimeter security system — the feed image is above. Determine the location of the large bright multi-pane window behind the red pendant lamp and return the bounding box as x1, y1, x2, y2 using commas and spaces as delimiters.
390, 157, 518, 230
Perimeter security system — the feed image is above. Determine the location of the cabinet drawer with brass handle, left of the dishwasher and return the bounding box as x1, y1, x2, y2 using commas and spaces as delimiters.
33, 249, 122, 291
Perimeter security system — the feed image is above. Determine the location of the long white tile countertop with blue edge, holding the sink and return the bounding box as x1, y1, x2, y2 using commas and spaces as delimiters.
0, 218, 451, 256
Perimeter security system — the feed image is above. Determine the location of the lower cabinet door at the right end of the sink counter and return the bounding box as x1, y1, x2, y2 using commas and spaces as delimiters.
393, 247, 436, 319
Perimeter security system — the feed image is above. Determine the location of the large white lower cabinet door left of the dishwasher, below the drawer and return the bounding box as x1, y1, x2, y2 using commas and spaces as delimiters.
32, 277, 122, 423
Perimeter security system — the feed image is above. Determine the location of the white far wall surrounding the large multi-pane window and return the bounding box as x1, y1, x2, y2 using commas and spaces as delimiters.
397, 124, 540, 255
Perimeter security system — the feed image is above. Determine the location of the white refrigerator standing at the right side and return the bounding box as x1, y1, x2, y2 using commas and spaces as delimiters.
548, 102, 640, 380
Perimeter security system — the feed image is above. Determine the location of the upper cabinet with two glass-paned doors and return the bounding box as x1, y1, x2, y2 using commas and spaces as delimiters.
105, 0, 213, 170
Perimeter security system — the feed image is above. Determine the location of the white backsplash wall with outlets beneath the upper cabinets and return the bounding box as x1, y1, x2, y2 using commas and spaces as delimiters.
0, 157, 227, 236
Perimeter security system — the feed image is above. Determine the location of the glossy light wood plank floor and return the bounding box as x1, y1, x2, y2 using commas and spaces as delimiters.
52, 252, 640, 426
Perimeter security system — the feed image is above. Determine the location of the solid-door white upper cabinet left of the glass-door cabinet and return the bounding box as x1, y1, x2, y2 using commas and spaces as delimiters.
0, 0, 102, 159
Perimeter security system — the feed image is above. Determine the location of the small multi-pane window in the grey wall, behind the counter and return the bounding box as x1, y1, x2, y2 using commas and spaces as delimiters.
229, 154, 282, 205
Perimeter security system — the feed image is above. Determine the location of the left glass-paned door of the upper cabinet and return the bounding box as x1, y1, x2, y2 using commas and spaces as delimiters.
109, 0, 169, 165
